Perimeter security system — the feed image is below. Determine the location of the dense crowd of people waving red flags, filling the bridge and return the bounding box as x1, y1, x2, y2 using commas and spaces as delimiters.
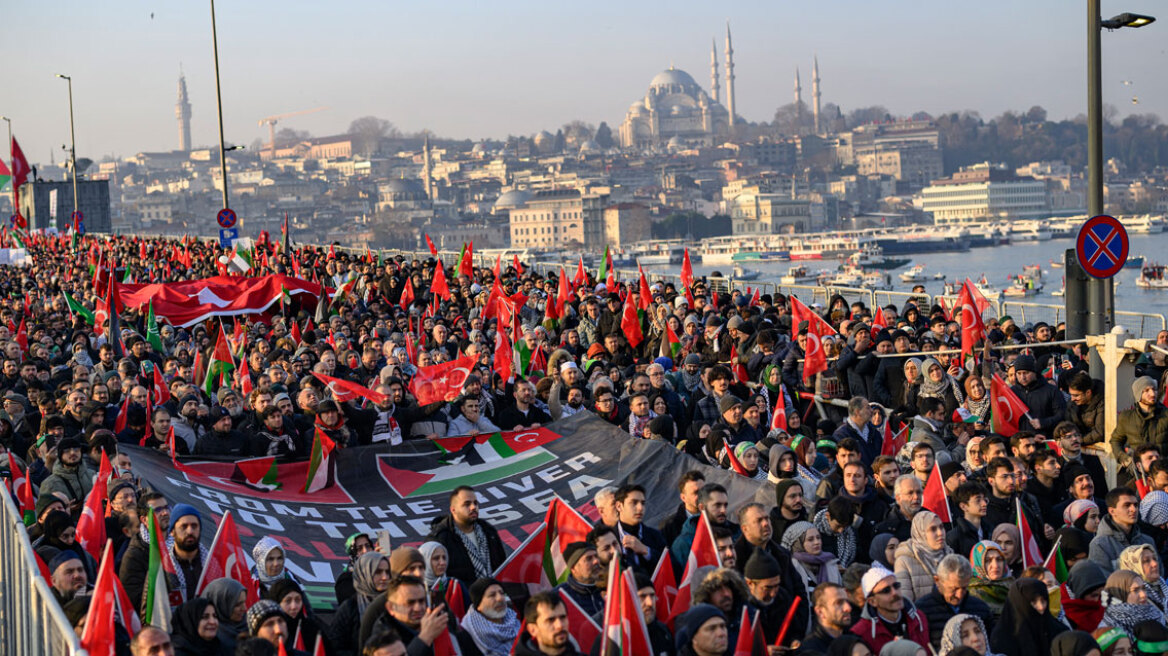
0, 231, 1168, 656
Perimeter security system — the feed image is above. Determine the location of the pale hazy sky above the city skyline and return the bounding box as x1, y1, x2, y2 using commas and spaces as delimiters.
0, 0, 1168, 161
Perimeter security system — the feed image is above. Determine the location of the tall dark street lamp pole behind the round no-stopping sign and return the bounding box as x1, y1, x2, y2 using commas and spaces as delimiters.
1066, 0, 1155, 368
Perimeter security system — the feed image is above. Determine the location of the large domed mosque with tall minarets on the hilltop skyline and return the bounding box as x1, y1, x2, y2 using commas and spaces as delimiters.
620, 23, 736, 148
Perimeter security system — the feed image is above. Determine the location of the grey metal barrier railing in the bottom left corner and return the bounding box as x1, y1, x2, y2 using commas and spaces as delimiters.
0, 478, 85, 656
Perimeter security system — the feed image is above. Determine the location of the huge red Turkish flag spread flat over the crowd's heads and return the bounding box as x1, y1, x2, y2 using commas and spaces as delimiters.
118, 274, 321, 328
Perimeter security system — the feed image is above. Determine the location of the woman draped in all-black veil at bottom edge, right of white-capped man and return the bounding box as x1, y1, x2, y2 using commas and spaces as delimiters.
989, 579, 1070, 656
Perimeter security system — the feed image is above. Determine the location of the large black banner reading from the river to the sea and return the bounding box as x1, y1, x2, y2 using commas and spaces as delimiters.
127, 413, 774, 609
